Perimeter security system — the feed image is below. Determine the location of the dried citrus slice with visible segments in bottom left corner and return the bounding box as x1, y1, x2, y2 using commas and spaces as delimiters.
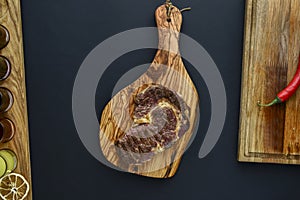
0, 173, 29, 200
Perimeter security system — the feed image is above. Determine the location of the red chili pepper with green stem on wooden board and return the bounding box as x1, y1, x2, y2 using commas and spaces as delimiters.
258, 54, 300, 107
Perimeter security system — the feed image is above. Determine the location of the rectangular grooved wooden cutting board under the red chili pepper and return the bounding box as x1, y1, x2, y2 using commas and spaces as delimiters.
238, 0, 300, 164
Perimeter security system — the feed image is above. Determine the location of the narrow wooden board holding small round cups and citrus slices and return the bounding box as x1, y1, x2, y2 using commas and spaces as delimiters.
0, 0, 32, 200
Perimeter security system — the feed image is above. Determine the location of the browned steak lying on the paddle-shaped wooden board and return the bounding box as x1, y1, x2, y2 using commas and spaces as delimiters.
115, 85, 190, 165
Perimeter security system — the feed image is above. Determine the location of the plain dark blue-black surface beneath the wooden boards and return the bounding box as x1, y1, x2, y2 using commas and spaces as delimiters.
22, 0, 300, 200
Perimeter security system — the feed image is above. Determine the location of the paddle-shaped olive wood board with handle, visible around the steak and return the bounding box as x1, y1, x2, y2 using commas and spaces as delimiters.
100, 5, 199, 178
